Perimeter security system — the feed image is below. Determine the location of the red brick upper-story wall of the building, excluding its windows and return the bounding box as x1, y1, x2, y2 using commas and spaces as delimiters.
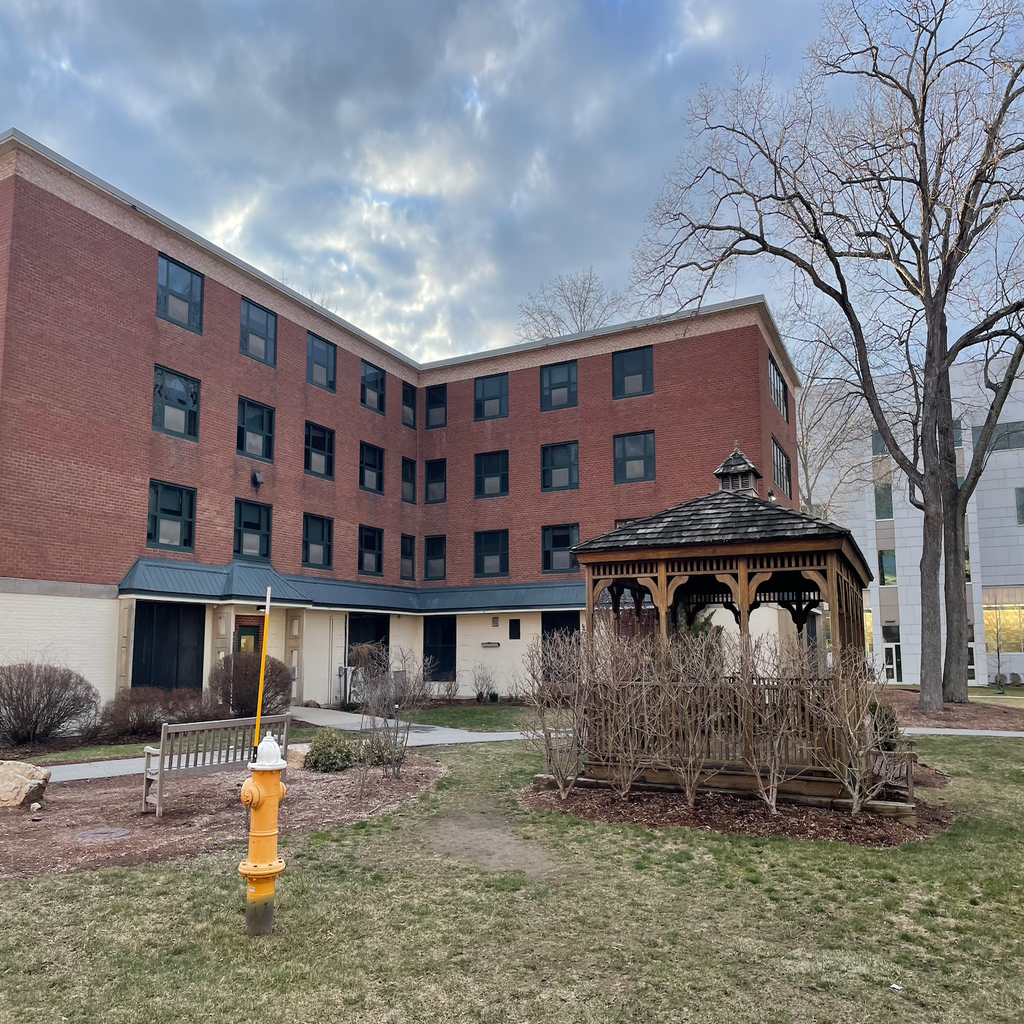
0, 161, 796, 586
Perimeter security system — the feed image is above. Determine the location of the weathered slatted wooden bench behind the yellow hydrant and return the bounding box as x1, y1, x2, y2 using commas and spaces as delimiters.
142, 715, 292, 818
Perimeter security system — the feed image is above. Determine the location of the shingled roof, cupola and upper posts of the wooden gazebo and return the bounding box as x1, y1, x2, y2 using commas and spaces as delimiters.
574, 449, 871, 647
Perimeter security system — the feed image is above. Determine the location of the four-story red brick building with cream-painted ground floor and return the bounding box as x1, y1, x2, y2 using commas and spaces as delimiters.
0, 132, 798, 701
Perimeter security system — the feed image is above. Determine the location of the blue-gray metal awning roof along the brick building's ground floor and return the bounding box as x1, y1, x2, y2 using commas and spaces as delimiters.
119, 558, 587, 614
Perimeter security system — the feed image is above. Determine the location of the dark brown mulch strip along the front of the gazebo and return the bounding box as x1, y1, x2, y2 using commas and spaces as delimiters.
520, 788, 952, 849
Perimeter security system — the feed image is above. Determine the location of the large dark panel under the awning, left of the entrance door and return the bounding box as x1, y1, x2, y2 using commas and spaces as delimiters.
131, 601, 206, 690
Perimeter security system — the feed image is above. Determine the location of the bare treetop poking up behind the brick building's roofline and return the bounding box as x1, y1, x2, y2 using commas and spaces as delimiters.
515, 266, 629, 341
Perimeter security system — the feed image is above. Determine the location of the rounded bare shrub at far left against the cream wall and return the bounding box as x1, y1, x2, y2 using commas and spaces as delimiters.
0, 662, 99, 744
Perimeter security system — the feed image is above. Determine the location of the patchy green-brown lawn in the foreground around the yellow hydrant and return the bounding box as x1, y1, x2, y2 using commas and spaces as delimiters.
0, 738, 1024, 1024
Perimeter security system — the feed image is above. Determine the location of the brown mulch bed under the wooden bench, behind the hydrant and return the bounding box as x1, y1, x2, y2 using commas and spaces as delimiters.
0, 757, 444, 881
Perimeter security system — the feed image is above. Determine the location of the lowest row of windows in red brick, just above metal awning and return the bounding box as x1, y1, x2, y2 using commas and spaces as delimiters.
146, 480, 580, 580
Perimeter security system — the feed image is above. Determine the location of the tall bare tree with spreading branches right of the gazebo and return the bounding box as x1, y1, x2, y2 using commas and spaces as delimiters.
635, 0, 1024, 710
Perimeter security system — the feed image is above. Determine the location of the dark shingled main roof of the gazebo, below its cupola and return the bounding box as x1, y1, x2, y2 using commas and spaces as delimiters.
574, 490, 863, 559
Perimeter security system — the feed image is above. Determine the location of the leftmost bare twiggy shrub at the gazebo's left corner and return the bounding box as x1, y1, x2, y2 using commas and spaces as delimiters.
515, 633, 592, 800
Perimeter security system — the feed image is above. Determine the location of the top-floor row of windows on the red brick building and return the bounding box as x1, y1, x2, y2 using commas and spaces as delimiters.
157, 254, 790, 430
